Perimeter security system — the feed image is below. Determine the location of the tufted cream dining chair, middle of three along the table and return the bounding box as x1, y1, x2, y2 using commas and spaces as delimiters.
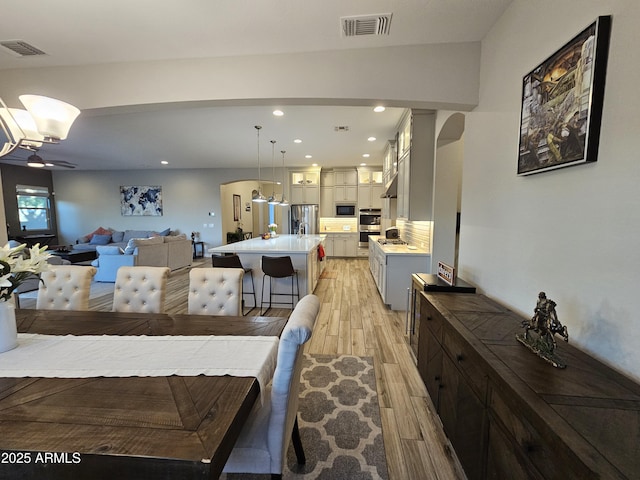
112, 266, 170, 313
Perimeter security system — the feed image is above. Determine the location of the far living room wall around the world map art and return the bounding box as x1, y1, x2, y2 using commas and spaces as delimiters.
53, 169, 256, 248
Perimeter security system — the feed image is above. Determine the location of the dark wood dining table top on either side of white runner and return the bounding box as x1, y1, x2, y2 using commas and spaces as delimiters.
0, 309, 287, 480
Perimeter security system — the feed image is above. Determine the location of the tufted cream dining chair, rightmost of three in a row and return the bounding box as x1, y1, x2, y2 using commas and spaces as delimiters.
188, 267, 244, 315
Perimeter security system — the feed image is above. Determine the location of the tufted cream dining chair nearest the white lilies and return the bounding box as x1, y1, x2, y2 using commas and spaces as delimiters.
36, 265, 96, 310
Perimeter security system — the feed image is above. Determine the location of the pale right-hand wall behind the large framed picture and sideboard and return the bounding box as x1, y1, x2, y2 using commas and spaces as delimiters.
459, 0, 640, 379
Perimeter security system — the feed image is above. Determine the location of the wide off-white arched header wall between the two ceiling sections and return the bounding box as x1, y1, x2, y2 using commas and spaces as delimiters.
0, 42, 480, 110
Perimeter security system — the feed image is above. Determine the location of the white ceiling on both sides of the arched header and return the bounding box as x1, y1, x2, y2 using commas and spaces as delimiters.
0, 0, 511, 169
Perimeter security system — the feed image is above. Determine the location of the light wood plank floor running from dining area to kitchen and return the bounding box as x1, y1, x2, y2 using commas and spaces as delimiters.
22, 258, 466, 480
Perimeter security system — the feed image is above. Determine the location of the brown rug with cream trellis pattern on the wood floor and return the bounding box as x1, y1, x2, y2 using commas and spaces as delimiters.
220, 355, 388, 480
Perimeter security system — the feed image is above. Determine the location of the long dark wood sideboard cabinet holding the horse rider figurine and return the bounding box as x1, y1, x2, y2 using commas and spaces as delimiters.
418, 292, 640, 480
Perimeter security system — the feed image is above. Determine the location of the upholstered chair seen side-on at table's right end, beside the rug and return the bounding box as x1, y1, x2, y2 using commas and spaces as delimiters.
223, 295, 320, 478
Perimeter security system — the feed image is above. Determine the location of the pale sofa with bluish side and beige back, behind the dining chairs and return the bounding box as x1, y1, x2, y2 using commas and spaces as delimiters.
92, 235, 193, 282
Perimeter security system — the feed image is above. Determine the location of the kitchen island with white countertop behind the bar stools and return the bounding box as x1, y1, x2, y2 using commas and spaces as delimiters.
209, 235, 326, 305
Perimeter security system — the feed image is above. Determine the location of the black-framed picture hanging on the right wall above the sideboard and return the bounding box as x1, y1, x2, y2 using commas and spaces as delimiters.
518, 16, 611, 175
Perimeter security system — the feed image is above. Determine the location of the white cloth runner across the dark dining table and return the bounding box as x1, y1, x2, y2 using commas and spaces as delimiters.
0, 333, 278, 404
